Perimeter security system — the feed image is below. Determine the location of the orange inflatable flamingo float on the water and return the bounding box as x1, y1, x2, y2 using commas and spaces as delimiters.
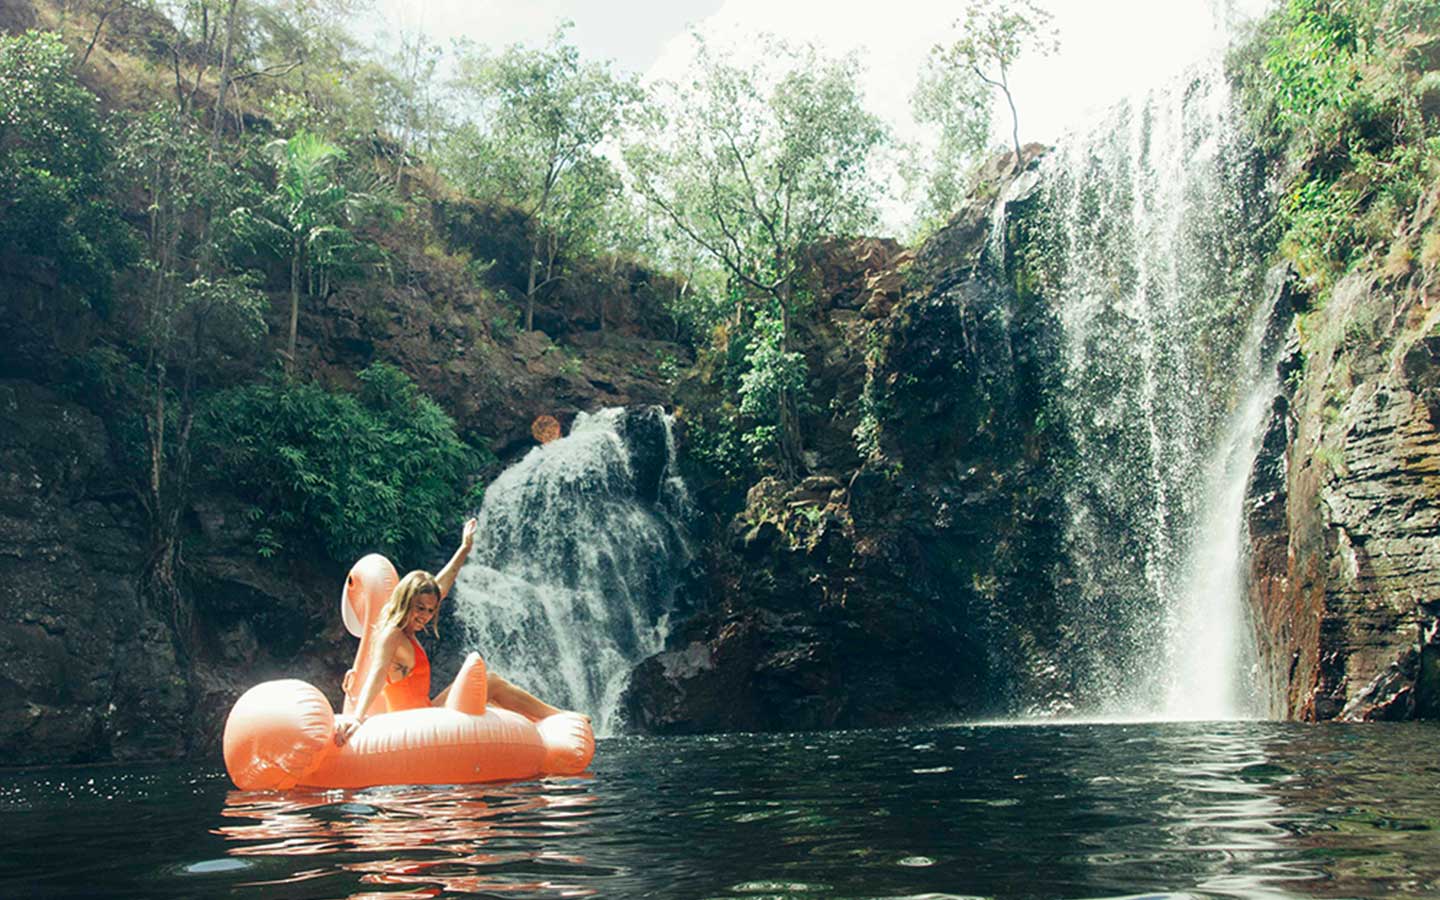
225, 554, 595, 791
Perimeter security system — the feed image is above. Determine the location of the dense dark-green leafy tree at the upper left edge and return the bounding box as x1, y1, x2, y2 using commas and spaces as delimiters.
0, 32, 135, 304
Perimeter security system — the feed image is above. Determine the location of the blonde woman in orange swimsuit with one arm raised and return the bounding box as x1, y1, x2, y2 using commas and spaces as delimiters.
336, 518, 560, 744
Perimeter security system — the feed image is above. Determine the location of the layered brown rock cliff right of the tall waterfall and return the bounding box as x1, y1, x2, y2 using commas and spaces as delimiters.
1250, 275, 1440, 720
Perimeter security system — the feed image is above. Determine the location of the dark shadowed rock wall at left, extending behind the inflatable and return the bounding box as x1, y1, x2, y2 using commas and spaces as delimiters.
0, 379, 343, 765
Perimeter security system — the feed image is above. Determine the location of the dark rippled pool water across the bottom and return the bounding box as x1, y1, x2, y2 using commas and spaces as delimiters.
0, 723, 1440, 900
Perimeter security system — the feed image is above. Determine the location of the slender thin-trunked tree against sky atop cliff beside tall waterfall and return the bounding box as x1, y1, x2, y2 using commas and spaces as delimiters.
922, 0, 1060, 168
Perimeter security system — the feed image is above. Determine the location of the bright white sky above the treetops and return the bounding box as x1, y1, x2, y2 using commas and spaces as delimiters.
374, 0, 1272, 227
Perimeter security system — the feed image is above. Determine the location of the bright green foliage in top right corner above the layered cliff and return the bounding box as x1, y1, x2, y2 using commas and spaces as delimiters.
1234, 0, 1440, 294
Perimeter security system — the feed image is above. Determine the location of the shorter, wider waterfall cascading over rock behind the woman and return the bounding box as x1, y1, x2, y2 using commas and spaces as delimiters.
456, 409, 690, 734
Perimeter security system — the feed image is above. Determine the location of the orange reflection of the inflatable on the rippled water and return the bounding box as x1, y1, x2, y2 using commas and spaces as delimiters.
213, 779, 612, 900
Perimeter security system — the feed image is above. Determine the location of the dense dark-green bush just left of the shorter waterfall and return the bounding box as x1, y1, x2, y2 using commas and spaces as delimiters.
199, 363, 484, 560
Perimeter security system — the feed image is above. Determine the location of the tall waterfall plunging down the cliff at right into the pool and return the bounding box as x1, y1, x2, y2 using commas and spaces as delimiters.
1041, 63, 1274, 719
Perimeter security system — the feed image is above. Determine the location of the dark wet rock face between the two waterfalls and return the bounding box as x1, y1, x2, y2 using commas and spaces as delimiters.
626, 151, 1063, 733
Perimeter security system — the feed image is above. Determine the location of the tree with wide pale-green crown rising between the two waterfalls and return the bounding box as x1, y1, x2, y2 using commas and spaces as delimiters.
625, 39, 887, 474
